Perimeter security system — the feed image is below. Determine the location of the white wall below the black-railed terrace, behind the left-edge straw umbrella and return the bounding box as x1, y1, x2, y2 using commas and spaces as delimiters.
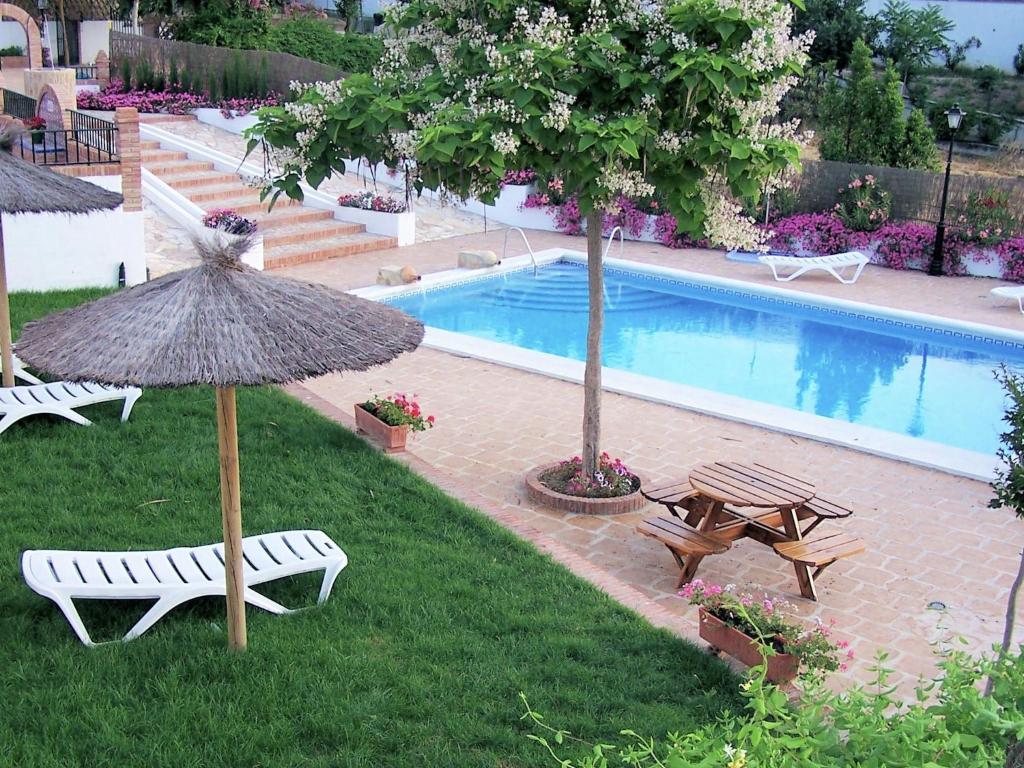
3, 176, 145, 291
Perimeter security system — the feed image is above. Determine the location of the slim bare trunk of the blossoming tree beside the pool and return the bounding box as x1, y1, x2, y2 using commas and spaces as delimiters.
583, 211, 604, 477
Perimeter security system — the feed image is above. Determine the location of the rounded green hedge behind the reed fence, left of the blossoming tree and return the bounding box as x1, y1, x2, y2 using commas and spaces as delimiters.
261, 18, 384, 73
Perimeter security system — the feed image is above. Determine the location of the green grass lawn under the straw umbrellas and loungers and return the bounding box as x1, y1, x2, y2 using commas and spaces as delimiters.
0, 292, 738, 768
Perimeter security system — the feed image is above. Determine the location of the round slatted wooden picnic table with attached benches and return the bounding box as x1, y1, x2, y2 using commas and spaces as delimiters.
637, 462, 865, 600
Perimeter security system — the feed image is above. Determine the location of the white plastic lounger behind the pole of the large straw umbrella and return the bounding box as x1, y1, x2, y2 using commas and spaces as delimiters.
22, 530, 348, 645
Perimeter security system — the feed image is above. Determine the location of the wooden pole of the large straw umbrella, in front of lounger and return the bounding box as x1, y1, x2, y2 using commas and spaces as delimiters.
217, 387, 247, 650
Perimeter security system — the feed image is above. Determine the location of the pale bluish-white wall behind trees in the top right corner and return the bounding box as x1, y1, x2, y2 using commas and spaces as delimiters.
865, 0, 1024, 72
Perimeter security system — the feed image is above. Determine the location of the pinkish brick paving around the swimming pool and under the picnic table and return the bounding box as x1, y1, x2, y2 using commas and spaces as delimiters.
285, 232, 1024, 683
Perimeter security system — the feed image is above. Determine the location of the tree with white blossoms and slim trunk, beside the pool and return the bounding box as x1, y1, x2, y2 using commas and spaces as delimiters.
250, 0, 811, 475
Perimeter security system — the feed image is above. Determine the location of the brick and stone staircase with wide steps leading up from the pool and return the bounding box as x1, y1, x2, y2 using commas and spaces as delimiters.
141, 141, 398, 269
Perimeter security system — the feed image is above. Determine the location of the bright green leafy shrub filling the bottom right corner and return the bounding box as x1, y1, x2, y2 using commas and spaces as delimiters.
520, 649, 1024, 768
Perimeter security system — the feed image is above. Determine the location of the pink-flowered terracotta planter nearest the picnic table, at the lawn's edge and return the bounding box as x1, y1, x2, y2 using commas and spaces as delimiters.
679, 579, 853, 683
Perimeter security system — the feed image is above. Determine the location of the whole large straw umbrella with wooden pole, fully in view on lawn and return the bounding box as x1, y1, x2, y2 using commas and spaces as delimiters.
17, 239, 423, 649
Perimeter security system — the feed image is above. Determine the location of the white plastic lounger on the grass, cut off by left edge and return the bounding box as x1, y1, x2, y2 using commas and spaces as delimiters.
0, 382, 142, 434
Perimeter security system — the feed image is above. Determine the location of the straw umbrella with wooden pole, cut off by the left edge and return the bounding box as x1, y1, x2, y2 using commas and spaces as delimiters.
0, 137, 124, 387
